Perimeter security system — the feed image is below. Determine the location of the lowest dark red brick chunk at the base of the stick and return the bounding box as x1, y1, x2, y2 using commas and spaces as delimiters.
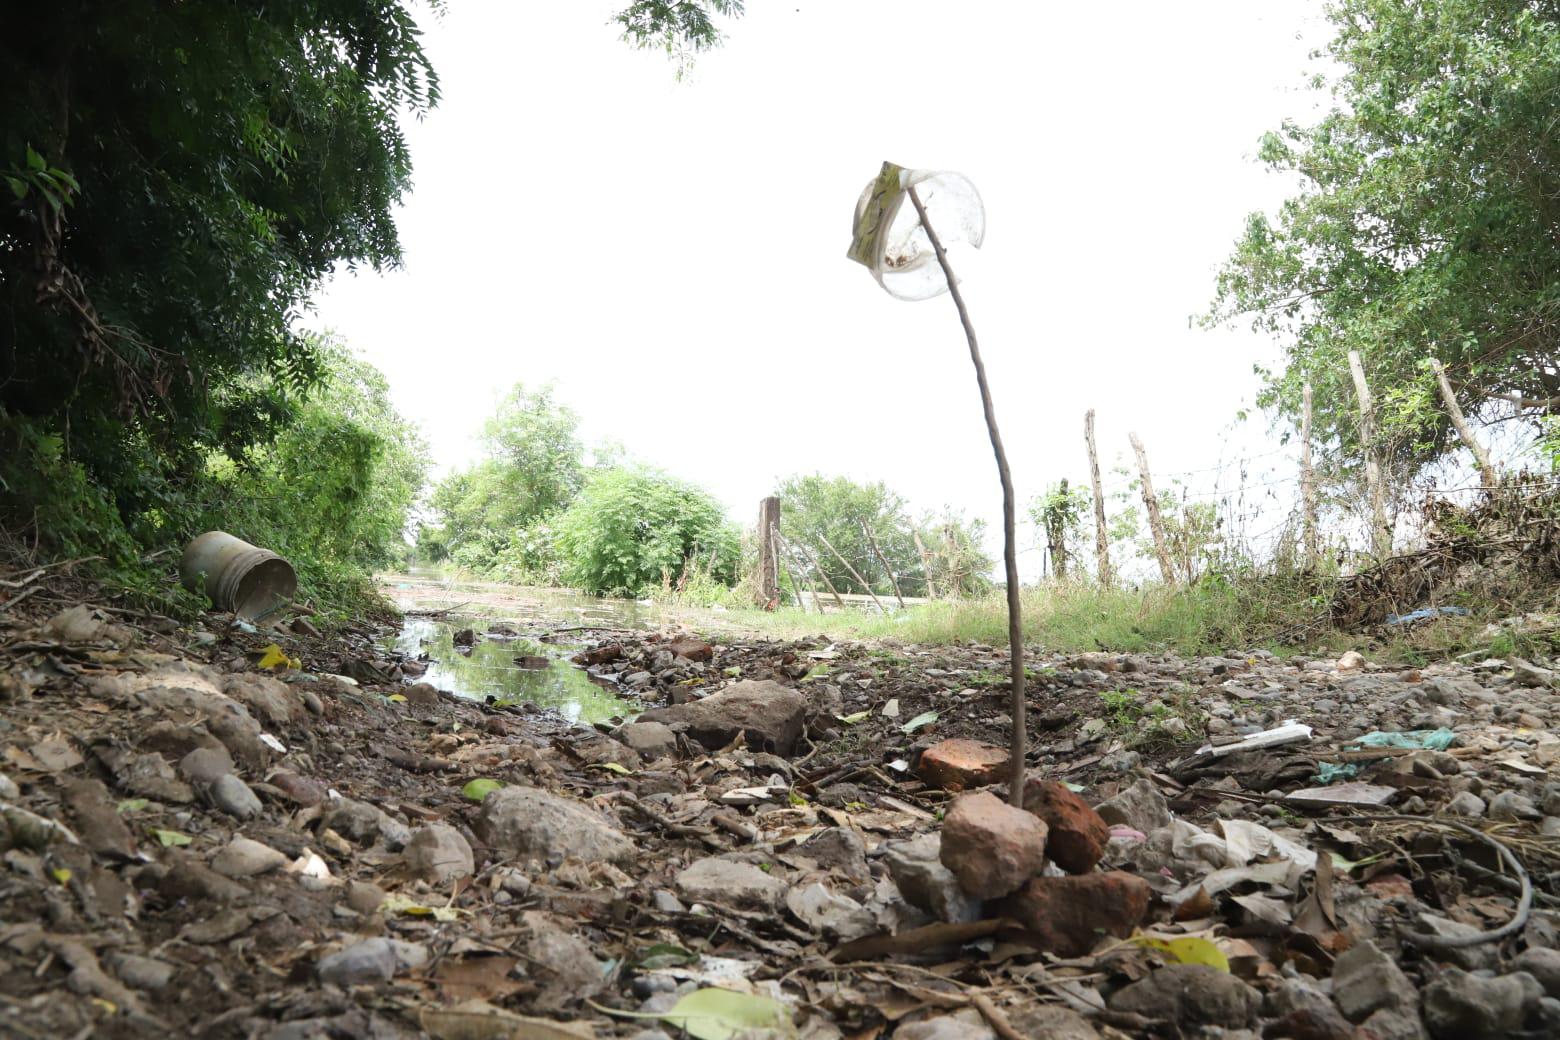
989, 870, 1153, 957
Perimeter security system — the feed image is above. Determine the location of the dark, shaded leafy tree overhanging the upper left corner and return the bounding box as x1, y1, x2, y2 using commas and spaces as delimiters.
0, 0, 437, 536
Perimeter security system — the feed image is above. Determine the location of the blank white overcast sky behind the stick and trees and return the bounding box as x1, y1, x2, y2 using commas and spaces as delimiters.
307, 0, 1326, 577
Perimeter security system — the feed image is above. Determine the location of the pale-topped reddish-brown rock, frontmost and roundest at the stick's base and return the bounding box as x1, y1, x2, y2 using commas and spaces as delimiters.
941, 791, 1045, 900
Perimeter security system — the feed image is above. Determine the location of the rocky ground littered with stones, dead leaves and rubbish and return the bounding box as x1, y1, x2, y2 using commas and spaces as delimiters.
0, 575, 1560, 1040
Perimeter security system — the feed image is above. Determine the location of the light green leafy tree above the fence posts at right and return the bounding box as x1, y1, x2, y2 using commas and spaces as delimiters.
1211, 0, 1560, 468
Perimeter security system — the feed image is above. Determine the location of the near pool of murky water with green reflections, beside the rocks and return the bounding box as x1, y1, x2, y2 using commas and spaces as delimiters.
387, 616, 640, 722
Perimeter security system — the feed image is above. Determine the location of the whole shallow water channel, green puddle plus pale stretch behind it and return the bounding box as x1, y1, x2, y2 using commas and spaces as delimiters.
381, 571, 661, 722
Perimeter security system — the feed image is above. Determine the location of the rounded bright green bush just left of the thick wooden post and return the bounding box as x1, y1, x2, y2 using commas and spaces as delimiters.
557, 466, 741, 596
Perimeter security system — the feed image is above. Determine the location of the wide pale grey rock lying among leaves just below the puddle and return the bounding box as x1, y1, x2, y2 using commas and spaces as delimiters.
476, 786, 636, 865
